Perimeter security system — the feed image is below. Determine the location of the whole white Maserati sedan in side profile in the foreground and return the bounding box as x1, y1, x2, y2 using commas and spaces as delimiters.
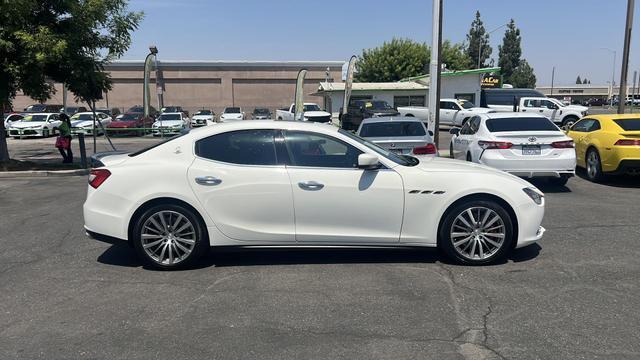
84, 120, 544, 269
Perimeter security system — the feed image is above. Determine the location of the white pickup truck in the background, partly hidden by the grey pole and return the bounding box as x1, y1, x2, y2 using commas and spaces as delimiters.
398, 99, 496, 126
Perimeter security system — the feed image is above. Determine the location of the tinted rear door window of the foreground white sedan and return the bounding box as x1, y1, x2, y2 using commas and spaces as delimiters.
196, 130, 276, 165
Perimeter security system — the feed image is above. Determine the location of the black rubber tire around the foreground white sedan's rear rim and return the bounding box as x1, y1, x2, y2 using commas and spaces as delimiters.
130, 204, 209, 270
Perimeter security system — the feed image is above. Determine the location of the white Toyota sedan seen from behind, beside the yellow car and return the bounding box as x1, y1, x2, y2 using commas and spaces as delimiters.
449, 113, 576, 185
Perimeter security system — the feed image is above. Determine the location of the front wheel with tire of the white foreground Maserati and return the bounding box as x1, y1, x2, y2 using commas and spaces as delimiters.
438, 200, 515, 265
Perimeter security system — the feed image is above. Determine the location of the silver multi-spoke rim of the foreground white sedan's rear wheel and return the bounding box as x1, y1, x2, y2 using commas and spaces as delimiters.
140, 210, 196, 265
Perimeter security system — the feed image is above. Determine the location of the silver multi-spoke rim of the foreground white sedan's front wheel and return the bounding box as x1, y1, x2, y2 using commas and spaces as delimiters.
450, 206, 506, 260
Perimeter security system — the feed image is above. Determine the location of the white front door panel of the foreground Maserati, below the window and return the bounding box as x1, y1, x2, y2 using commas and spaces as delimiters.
287, 167, 404, 243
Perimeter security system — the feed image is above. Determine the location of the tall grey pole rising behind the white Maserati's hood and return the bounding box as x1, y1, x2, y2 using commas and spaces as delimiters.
429, 0, 442, 146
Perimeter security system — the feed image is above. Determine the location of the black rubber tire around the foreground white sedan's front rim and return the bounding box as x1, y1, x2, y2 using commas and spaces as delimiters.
438, 200, 515, 265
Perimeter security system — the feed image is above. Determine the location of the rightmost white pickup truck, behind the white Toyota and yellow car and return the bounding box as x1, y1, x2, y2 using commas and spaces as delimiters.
512, 97, 589, 127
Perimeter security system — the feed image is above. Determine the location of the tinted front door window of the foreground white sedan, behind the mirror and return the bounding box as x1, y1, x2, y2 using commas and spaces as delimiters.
284, 131, 362, 168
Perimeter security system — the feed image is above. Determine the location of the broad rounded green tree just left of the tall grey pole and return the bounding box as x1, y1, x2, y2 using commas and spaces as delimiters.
355, 38, 430, 82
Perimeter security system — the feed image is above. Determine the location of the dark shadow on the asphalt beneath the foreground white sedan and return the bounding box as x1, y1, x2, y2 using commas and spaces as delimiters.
97, 241, 542, 270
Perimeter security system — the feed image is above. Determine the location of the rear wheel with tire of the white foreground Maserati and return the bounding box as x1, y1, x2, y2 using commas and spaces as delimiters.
132, 204, 209, 270
